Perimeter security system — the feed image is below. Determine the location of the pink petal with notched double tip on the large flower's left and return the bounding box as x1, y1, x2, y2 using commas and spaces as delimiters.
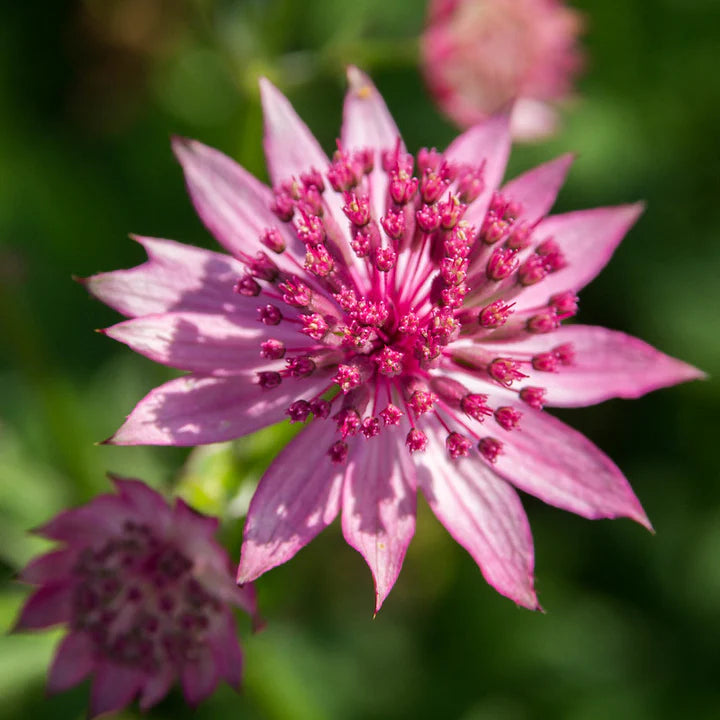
82, 237, 247, 317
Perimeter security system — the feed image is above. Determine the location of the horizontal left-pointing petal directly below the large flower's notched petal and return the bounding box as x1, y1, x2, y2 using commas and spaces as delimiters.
103, 310, 307, 375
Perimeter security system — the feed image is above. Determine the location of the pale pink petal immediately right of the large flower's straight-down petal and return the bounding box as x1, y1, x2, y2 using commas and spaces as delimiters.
418, 423, 540, 610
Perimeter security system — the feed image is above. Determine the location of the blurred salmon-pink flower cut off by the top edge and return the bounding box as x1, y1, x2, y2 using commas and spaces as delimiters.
422, 0, 582, 140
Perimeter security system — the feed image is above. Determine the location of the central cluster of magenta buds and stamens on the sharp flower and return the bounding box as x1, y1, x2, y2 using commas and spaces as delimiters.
235, 140, 577, 463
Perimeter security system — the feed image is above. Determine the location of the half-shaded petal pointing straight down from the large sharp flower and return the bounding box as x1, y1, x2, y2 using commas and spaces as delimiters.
342, 430, 415, 612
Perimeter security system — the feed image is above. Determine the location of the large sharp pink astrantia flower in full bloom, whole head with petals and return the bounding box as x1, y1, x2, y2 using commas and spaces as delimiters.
83, 69, 699, 608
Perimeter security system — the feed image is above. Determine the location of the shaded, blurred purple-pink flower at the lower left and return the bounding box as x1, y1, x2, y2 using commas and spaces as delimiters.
17, 478, 255, 716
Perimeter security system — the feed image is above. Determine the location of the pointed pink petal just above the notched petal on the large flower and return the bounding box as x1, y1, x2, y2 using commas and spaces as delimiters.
173, 137, 305, 270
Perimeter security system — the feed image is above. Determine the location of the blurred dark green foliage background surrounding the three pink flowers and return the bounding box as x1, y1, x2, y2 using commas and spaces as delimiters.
0, 0, 720, 720
